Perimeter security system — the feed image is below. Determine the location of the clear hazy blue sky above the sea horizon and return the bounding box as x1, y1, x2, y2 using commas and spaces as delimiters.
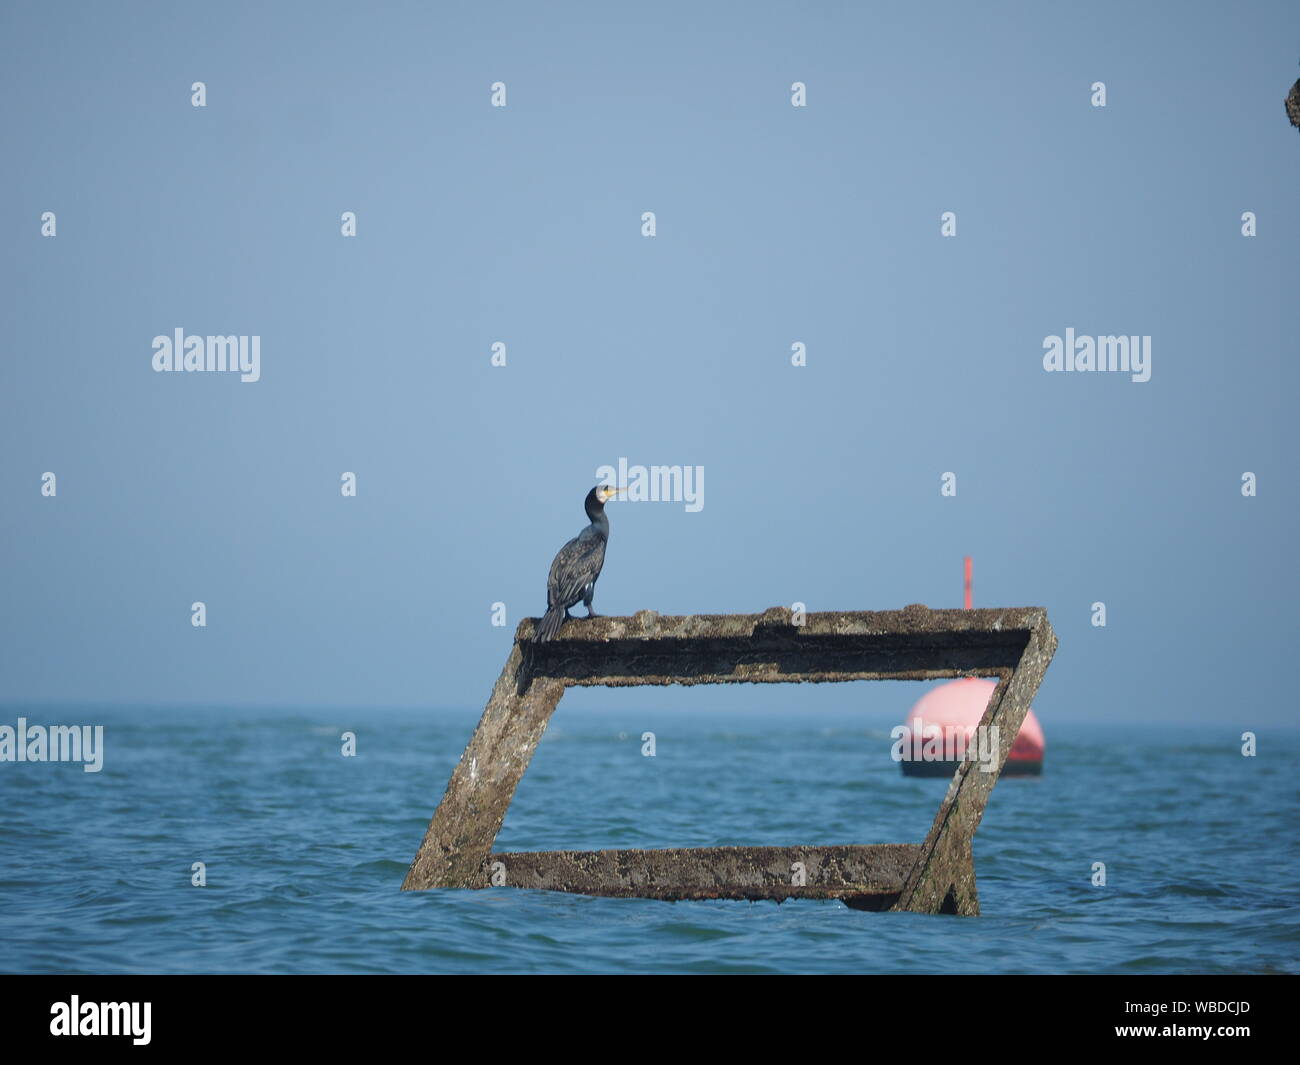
0, 0, 1300, 730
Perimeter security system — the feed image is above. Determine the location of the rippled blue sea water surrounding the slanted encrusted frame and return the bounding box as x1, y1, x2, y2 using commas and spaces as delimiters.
0, 705, 1300, 974
